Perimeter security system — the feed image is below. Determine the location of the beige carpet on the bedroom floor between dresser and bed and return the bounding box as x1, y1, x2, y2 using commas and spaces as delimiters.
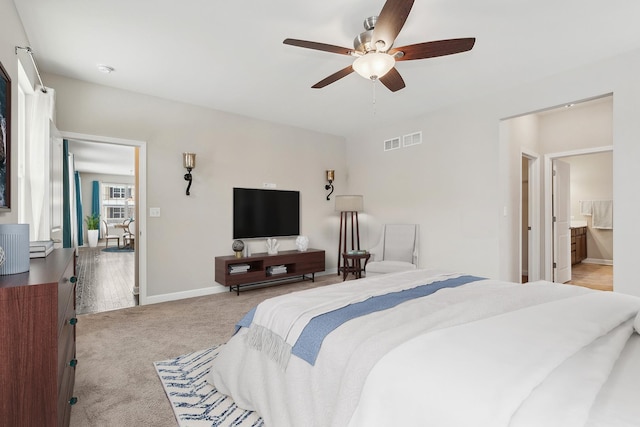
71, 274, 342, 427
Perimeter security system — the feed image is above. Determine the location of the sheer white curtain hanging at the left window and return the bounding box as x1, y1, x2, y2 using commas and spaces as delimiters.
24, 86, 55, 241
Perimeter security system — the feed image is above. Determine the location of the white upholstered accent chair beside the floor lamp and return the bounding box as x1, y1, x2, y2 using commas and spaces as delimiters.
365, 224, 420, 277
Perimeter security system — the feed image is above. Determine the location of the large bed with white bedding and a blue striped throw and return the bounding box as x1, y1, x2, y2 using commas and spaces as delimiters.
207, 270, 640, 427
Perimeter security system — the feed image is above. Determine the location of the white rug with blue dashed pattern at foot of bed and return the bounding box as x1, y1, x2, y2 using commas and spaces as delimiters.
154, 346, 264, 427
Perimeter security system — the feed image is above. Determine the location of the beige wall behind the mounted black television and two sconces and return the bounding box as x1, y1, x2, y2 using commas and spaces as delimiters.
44, 75, 346, 300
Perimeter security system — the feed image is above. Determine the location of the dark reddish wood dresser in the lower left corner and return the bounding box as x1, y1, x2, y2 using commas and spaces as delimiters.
0, 249, 77, 427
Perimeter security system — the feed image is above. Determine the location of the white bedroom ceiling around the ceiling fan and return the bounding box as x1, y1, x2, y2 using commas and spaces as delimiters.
14, 0, 640, 140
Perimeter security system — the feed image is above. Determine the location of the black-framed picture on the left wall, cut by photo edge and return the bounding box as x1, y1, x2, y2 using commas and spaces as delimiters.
0, 63, 11, 211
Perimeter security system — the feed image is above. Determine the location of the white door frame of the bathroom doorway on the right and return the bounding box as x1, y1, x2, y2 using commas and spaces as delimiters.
544, 145, 613, 281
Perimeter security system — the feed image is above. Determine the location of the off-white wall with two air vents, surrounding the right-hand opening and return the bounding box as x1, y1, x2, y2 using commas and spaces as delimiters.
347, 51, 640, 295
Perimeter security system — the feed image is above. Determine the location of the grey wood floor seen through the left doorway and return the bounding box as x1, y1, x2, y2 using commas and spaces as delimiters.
76, 246, 137, 314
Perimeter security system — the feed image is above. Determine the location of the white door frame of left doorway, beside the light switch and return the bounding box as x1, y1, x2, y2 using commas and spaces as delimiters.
60, 131, 147, 305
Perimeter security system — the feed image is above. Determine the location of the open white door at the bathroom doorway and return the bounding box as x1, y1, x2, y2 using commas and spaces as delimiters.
553, 160, 571, 283
